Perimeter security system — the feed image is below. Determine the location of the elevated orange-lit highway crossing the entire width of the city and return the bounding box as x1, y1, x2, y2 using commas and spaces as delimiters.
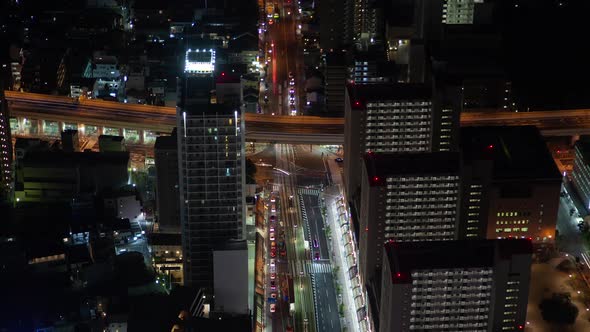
4, 91, 590, 144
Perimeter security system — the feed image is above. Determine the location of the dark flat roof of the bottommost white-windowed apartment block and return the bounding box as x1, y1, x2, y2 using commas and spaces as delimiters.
385, 239, 533, 283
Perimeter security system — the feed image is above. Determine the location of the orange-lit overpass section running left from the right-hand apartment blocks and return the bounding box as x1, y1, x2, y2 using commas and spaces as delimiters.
4, 91, 344, 144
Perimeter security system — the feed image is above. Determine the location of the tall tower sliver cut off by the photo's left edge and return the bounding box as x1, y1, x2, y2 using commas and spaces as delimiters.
0, 89, 13, 201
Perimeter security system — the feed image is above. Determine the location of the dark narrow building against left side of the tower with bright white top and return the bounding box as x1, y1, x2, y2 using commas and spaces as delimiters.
154, 129, 180, 233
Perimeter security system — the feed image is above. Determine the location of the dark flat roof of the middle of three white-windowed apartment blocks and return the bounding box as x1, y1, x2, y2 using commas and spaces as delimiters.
364, 152, 461, 185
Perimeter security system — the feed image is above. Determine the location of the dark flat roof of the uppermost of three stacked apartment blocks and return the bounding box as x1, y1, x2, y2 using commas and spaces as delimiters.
347, 83, 432, 104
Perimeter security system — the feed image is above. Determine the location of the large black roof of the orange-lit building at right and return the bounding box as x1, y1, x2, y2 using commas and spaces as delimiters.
460, 126, 561, 181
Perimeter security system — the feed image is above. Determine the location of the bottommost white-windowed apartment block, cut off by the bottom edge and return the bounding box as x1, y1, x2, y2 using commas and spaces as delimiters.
378, 239, 532, 332
